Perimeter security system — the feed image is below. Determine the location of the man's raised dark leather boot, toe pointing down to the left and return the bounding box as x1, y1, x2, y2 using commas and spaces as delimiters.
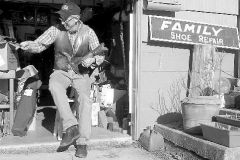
58, 125, 80, 151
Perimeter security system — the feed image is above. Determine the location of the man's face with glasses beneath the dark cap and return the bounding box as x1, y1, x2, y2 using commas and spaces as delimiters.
61, 16, 79, 33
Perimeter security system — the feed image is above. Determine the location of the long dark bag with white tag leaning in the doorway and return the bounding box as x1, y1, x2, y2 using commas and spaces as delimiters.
12, 77, 41, 137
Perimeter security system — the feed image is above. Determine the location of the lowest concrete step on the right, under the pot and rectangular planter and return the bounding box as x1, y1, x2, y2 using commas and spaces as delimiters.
154, 124, 240, 160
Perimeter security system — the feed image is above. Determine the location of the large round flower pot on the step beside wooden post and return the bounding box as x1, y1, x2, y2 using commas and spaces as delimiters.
182, 96, 221, 134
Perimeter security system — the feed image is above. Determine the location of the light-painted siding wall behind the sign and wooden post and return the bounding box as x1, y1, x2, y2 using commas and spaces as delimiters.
137, 0, 238, 134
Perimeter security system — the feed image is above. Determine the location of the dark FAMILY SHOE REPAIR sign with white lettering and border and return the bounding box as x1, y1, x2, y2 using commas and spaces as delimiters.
149, 16, 239, 49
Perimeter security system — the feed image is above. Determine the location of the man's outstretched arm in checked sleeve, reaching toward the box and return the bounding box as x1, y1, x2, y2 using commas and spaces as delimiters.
20, 26, 59, 53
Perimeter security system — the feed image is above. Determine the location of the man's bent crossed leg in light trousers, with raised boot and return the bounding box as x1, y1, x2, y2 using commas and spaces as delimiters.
49, 70, 80, 151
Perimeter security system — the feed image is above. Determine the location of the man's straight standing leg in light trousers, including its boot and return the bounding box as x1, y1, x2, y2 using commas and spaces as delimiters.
73, 74, 92, 157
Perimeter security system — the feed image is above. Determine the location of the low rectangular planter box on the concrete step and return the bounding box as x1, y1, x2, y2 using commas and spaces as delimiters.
201, 122, 240, 147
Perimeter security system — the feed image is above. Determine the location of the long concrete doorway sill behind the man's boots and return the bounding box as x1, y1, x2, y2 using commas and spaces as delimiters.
0, 136, 132, 154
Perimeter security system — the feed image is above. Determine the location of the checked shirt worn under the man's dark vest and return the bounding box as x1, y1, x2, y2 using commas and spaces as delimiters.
31, 24, 99, 53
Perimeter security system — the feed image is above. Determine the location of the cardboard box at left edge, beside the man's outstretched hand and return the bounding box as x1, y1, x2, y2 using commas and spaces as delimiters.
0, 43, 18, 70
